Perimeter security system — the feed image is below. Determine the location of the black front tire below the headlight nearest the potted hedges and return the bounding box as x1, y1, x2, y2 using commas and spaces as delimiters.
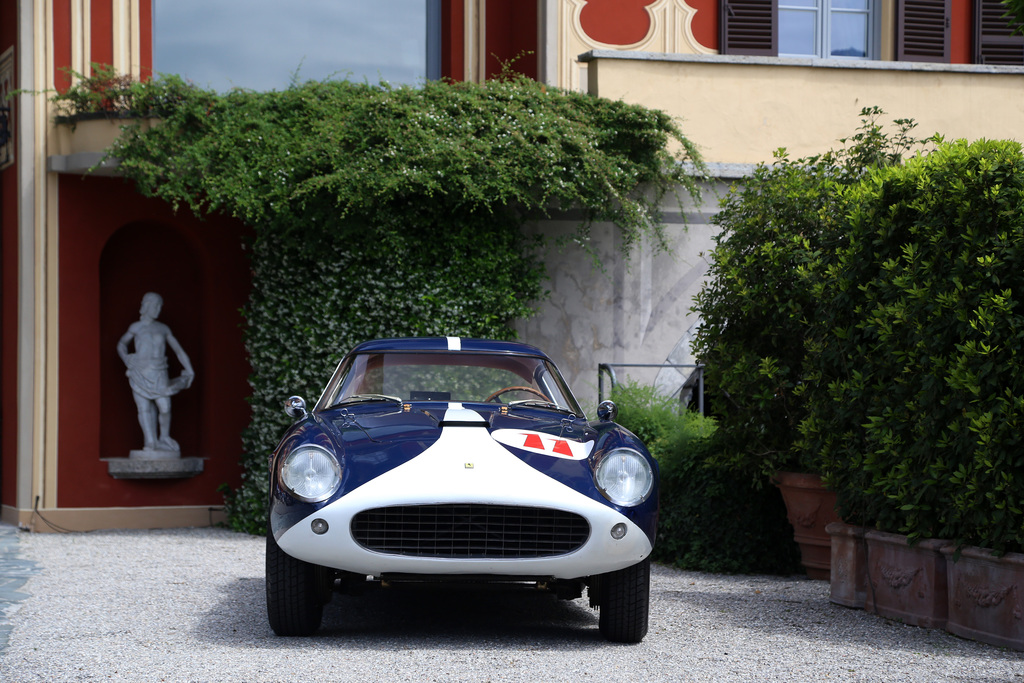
598, 558, 650, 643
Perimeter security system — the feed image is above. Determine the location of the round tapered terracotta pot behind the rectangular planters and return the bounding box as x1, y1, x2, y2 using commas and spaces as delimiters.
773, 472, 840, 581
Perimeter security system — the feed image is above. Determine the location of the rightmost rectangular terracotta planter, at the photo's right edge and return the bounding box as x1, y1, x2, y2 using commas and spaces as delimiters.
942, 546, 1024, 650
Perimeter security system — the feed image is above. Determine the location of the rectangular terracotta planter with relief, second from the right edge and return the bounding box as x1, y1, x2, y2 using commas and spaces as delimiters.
864, 530, 949, 629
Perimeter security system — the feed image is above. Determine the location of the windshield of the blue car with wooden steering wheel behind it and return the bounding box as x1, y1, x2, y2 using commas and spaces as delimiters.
321, 352, 583, 417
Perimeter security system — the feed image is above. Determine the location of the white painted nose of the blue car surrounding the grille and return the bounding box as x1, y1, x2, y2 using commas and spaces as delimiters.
271, 419, 651, 579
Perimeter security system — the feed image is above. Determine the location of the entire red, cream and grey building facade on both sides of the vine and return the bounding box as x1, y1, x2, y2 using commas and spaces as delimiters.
0, 0, 1024, 530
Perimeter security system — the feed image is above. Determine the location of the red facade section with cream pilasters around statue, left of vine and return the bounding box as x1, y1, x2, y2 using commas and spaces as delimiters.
0, 0, 249, 530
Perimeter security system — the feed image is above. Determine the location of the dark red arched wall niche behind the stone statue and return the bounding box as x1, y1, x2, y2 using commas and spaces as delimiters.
99, 221, 203, 458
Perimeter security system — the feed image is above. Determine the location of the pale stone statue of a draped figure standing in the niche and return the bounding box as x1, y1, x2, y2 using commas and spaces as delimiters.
118, 292, 196, 458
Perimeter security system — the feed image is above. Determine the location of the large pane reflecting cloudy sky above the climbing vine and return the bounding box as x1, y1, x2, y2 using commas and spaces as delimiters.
154, 0, 426, 91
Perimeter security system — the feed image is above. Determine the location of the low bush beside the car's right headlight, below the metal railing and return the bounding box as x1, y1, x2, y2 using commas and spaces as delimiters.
612, 383, 800, 574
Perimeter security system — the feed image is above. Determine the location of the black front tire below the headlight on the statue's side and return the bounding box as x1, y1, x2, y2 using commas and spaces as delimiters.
266, 525, 330, 636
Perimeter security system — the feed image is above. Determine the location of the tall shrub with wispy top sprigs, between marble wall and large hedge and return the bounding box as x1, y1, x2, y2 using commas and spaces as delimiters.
693, 108, 933, 483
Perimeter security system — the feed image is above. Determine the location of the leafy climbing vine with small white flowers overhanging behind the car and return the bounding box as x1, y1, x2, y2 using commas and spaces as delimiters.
90, 77, 699, 533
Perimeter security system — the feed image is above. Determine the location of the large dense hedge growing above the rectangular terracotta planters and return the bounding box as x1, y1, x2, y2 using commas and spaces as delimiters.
803, 140, 1024, 551
